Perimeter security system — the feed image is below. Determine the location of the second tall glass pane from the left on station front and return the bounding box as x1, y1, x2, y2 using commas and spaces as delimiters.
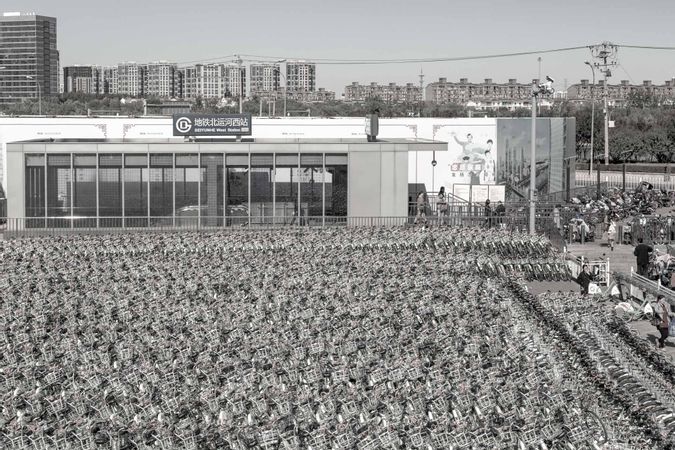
47, 154, 72, 227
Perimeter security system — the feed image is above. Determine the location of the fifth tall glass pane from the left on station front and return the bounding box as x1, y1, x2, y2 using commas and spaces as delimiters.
124, 155, 148, 227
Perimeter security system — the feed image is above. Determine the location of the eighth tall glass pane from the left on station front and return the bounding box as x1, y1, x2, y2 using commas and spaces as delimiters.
200, 154, 223, 226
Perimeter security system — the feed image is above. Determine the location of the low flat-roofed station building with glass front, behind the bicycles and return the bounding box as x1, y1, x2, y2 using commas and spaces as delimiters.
7, 139, 447, 228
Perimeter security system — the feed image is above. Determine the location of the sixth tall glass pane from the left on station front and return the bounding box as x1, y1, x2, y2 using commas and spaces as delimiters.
150, 154, 174, 225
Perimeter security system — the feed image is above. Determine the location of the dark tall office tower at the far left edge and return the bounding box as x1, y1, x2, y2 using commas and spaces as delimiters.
0, 13, 59, 103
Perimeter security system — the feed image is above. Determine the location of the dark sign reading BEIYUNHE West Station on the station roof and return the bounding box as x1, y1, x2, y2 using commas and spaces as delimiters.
173, 114, 252, 136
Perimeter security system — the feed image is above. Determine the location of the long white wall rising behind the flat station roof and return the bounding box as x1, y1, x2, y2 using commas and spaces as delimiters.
0, 117, 496, 194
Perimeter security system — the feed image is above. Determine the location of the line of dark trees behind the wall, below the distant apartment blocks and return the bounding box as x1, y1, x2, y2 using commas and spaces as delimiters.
0, 92, 675, 163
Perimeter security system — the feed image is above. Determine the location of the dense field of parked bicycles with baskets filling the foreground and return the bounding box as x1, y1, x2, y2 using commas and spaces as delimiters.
0, 228, 675, 450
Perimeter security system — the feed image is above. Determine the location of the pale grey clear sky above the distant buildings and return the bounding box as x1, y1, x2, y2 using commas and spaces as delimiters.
5, 0, 675, 95
